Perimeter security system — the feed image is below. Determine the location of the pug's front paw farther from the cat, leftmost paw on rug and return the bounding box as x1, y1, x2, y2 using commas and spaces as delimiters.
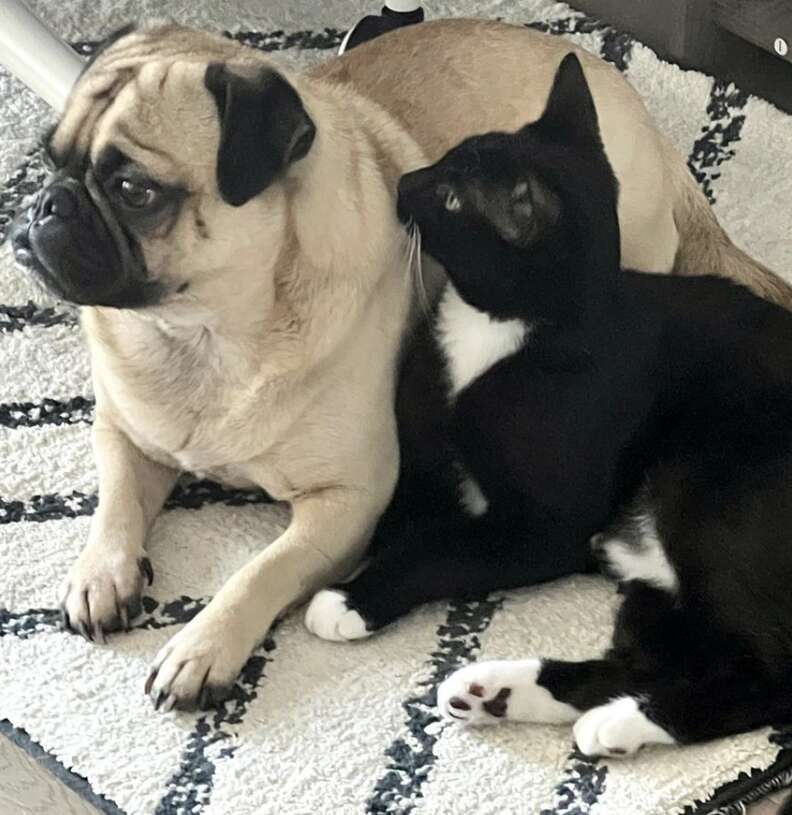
60, 545, 154, 643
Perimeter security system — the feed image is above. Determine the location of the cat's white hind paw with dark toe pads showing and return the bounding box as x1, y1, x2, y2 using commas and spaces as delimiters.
437, 659, 580, 725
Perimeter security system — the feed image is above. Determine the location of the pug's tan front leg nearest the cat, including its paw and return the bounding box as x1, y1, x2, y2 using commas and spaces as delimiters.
146, 488, 374, 710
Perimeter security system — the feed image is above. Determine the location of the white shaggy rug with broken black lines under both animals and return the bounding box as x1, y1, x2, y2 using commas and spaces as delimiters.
0, 0, 792, 815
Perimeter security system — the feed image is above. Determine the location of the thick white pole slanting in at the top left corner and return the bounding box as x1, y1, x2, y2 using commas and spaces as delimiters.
0, 0, 85, 113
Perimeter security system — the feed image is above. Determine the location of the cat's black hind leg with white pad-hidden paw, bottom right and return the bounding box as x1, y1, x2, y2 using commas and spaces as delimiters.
572, 581, 792, 756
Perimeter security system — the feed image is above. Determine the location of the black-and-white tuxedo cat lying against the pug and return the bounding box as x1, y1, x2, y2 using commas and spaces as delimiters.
308, 55, 792, 755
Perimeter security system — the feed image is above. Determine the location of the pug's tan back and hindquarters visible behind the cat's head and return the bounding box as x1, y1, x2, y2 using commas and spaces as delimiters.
318, 20, 792, 307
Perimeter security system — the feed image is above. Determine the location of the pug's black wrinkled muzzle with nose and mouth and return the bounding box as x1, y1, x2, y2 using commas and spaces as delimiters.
10, 173, 162, 308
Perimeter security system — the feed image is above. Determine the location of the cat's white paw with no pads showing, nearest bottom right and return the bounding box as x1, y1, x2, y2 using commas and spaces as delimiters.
573, 696, 676, 757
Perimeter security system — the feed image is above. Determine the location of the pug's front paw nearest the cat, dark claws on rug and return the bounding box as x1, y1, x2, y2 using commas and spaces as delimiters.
145, 610, 254, 712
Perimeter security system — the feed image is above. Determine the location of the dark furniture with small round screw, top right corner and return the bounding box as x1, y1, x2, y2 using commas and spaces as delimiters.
574, 0, 792, 113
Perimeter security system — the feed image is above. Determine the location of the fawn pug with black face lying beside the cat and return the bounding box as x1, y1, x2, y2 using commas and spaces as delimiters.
7, 15, 792, 710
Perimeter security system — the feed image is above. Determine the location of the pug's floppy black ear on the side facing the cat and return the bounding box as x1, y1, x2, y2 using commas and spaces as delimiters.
204, 62, 316, 207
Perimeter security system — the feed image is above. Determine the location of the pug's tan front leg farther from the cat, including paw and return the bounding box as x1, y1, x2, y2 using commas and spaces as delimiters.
60, 416, 177, 642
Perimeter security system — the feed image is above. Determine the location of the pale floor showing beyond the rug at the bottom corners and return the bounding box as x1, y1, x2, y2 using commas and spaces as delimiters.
0, 736, 786, 815
